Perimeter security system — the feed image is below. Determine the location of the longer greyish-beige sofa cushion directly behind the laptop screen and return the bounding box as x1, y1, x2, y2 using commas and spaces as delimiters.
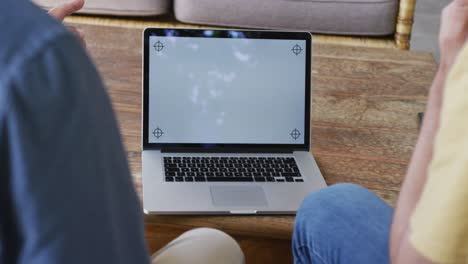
174, 0, 398, 36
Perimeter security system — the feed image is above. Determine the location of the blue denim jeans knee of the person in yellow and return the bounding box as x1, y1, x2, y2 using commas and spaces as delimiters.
292, 184, 393, 264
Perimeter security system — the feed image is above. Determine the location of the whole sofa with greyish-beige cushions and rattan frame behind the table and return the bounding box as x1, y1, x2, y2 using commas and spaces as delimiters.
33, 0, 415, 49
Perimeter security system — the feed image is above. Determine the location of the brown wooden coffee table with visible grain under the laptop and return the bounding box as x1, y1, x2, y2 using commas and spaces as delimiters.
75, 24, 436, 263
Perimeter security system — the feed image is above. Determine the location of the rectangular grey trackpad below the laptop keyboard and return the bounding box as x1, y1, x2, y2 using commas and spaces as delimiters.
210, 186, 268, 207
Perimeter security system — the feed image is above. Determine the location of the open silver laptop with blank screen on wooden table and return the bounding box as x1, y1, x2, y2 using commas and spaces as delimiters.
142, 28, 326, 214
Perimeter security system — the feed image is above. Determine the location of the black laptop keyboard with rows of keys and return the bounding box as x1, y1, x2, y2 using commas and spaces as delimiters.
164, 157, 304, 182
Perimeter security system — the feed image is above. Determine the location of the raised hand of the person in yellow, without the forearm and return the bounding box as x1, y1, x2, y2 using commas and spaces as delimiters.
439, 0, 468, 70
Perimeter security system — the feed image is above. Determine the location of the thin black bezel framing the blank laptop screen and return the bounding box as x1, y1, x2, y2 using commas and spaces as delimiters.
142, 28, 312, 152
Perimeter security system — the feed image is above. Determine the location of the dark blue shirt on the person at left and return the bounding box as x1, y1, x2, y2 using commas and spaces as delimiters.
0, 0, 149, 264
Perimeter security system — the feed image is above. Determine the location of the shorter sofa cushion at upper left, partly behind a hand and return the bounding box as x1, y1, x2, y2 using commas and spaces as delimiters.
33, 0, 172, 16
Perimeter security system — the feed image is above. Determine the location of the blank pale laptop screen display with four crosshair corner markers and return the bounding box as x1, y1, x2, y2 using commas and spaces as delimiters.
148, 31, 306, 144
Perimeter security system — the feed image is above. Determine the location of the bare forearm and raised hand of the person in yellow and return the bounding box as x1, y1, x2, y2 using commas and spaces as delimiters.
390, 0, 468, 264
